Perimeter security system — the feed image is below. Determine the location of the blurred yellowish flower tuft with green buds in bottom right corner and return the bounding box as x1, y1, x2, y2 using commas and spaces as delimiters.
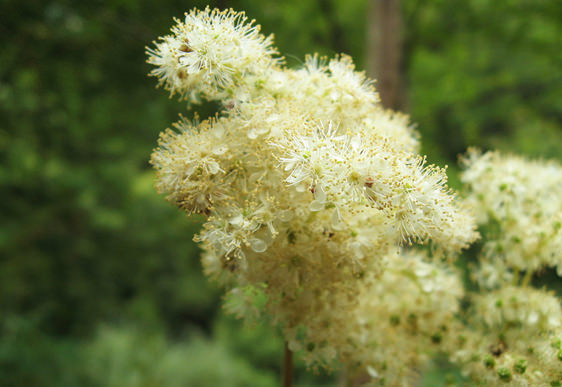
449, 286, 562, 386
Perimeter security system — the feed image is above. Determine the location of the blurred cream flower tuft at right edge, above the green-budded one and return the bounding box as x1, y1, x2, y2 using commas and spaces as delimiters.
462, 150, 562, 276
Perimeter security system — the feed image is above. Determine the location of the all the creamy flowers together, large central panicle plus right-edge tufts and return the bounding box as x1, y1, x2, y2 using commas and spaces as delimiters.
148, 8, 562, 386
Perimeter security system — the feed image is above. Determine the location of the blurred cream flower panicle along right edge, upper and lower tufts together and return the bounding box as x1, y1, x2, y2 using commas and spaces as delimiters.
450, 150, 562, 386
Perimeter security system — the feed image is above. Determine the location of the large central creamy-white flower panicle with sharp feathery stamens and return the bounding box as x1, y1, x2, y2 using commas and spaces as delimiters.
148, 9, 478, 380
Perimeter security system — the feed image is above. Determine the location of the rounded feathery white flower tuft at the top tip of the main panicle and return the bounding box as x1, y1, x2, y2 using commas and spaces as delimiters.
147, 8, 277, 99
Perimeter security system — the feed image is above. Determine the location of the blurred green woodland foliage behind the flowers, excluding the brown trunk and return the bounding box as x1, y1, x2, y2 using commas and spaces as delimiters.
0, 0, 562, 386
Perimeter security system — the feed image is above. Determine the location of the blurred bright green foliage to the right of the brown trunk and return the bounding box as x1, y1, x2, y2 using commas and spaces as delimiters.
405, 0, 562, 161
